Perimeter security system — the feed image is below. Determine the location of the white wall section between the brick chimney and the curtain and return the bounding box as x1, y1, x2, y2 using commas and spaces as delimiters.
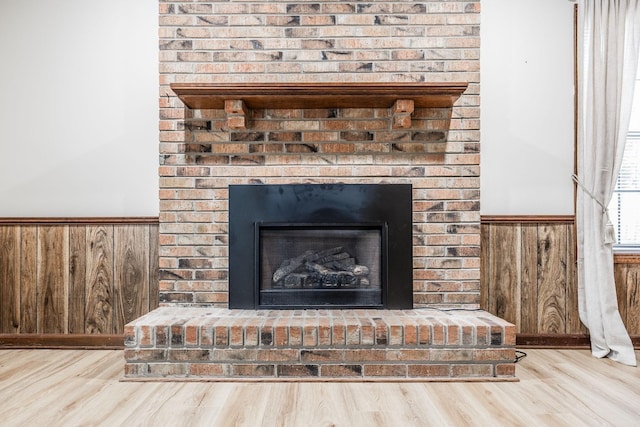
480, 0, 574, 215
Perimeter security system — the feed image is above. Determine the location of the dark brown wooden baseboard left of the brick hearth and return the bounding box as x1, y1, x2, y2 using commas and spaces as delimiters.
0, 334, 124, 350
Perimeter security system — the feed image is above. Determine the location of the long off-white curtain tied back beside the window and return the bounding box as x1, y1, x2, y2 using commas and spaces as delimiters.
574, 0, 640, 366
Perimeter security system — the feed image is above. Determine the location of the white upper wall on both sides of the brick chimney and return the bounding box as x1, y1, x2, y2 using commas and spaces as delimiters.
0, 0, 573, 217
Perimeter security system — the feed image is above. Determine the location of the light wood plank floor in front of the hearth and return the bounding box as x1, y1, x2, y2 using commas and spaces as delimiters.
0, 350, 640, 427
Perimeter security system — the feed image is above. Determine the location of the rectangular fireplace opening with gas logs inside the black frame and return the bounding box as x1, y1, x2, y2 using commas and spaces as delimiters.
256, 224, 387, 307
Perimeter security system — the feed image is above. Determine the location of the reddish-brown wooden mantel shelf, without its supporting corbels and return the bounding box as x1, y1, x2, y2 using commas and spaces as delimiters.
171, 82, 467, 109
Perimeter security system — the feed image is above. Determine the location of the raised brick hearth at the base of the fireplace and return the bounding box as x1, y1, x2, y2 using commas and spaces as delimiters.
125, 307, 515, 381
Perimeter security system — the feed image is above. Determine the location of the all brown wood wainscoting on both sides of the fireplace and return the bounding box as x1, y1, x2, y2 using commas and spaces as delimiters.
0, 217, 640, 347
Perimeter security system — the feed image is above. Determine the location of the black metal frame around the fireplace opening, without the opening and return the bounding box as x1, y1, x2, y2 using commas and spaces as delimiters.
229, 184, 413, 309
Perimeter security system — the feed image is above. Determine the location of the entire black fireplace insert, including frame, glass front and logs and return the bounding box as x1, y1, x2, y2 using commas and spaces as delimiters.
229, 184, 413, 309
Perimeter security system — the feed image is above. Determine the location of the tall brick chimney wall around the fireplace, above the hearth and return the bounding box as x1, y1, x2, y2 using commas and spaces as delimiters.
159, 0, 480, 308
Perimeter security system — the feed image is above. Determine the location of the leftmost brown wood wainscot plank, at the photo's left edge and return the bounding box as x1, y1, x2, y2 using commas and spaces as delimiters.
0, 227, 20, 334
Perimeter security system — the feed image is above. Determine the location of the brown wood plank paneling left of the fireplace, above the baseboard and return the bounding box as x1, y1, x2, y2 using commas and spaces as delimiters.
0, 219, 158, 334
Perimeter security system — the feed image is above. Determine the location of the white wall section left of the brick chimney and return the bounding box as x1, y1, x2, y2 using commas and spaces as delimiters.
0, 0, 158, 217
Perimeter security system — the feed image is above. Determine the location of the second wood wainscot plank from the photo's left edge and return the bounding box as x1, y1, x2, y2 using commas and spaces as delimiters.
19, 225, 38, 334
